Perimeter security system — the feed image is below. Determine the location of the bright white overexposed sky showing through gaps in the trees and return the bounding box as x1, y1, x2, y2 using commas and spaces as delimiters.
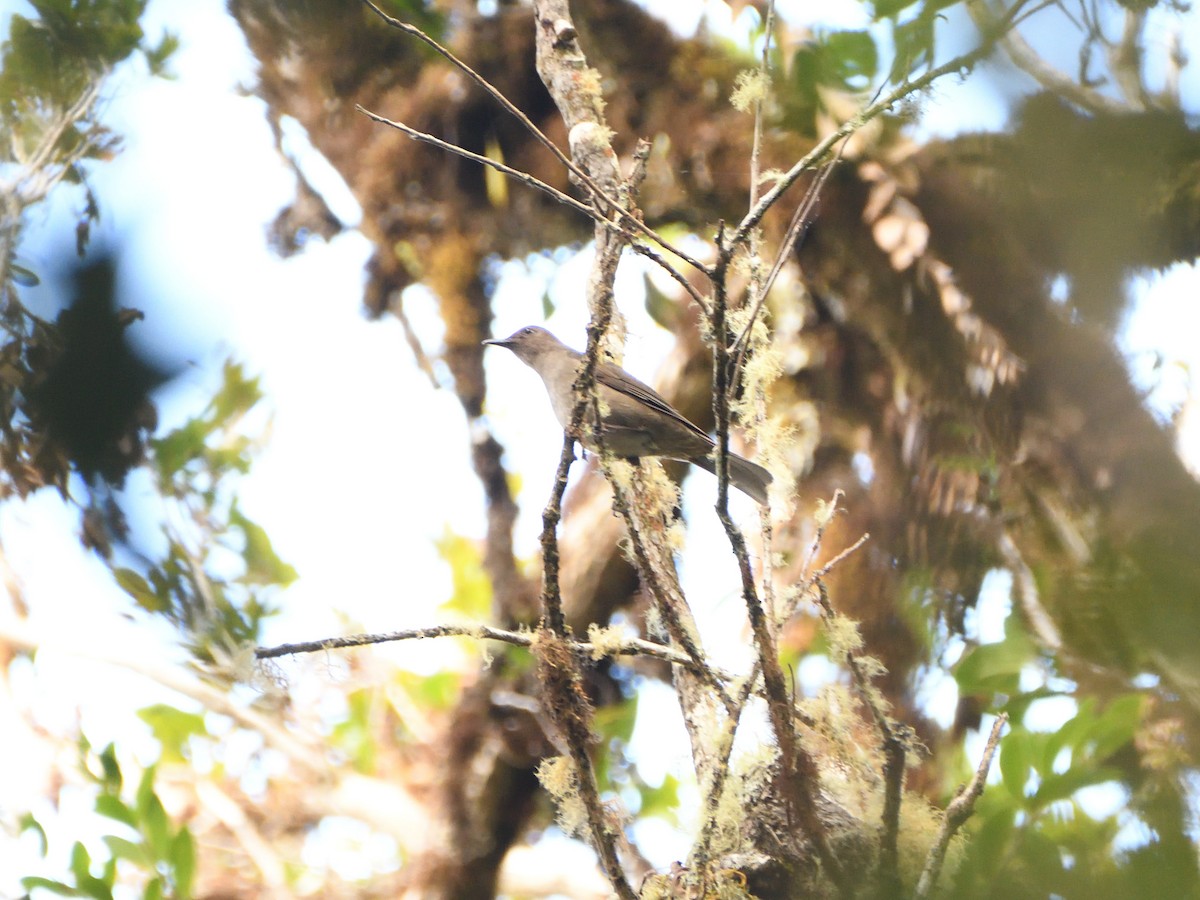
0, 0, 1200, 895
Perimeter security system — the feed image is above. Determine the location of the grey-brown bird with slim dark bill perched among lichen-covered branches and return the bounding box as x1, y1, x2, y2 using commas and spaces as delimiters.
484, 325, 770, 504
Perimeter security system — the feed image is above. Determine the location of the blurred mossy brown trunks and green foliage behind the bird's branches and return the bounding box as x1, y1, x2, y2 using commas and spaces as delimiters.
0, 0, 1200, 898
